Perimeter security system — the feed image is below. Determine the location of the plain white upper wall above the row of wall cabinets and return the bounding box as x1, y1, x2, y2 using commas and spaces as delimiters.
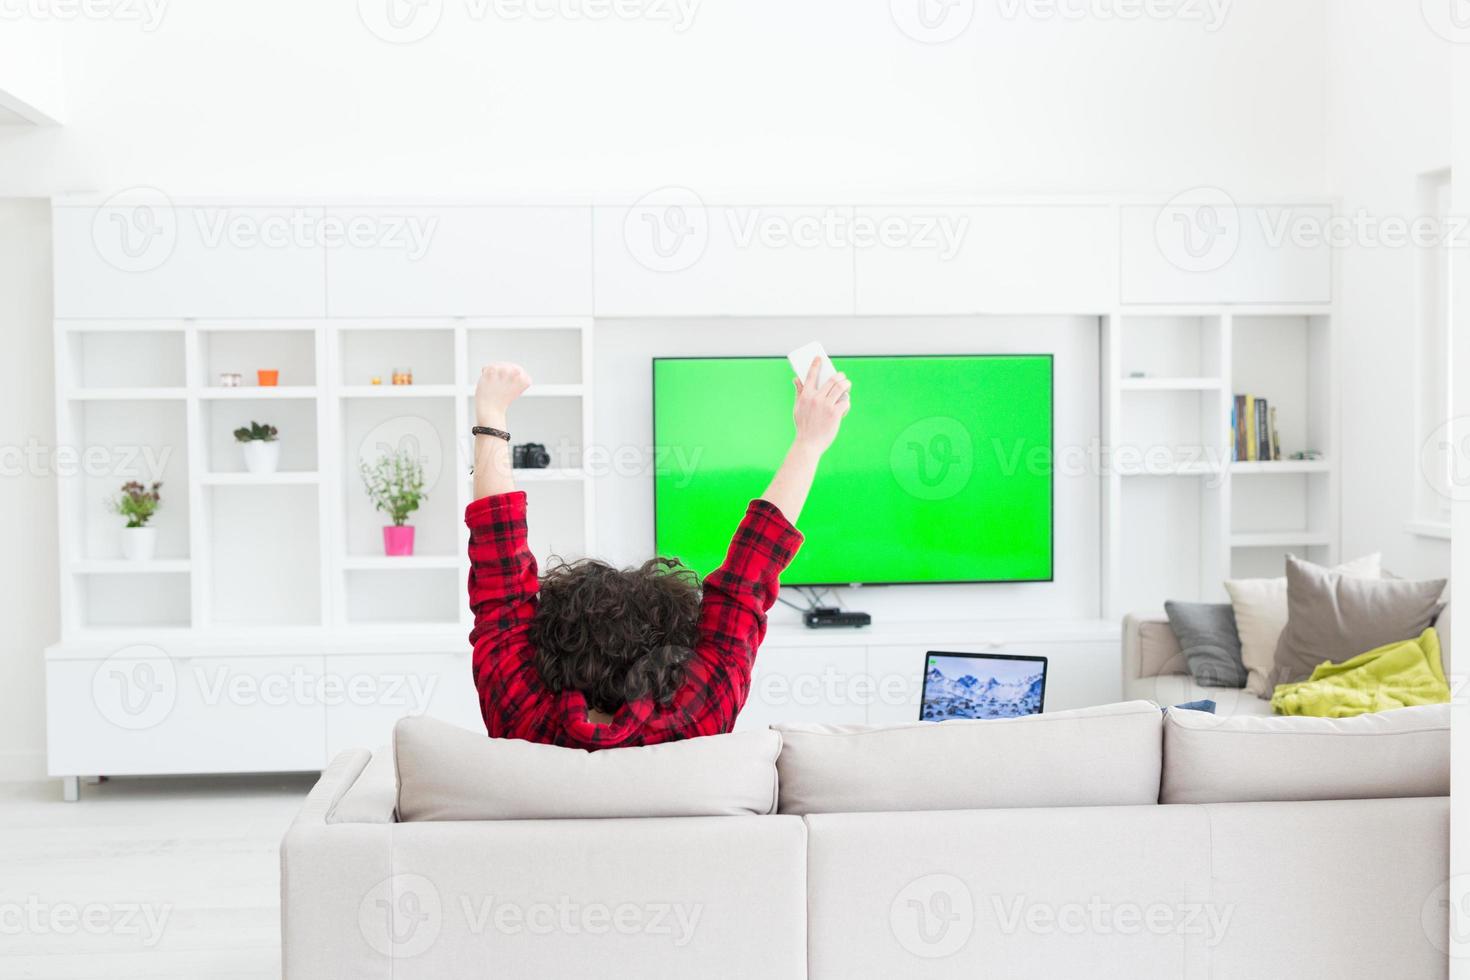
0, 0, 1329, 203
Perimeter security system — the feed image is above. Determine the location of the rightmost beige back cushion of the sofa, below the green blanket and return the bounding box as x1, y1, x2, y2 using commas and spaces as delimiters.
1160, 704, 1449, 804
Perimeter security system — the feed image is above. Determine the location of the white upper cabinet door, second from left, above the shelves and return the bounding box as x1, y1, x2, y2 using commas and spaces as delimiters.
326, 206, 592, 317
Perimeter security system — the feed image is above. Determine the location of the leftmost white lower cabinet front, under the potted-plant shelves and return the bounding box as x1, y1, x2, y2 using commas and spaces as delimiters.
46, 645, 326, 776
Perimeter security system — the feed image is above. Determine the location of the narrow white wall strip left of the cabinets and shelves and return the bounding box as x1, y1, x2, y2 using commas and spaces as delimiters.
0, 198, 60, 780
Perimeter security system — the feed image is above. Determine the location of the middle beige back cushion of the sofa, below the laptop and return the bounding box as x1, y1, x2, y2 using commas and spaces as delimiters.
775, 701, 1163, 814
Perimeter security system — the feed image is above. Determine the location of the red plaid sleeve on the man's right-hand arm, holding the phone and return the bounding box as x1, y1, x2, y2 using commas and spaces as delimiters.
650, 500, 801, 741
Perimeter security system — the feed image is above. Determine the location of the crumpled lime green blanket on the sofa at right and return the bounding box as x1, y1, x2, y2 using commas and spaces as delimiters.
1272, 627, 1449, 718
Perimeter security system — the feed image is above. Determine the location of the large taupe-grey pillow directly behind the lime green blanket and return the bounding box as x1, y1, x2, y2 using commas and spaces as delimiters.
1272, 555, 1445, 685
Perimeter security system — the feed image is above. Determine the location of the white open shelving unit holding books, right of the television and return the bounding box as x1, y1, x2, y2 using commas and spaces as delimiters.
1101, 304, 1339, 617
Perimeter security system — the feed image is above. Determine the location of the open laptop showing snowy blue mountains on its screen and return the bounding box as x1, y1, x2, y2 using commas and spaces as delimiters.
919, 651, 1047, 721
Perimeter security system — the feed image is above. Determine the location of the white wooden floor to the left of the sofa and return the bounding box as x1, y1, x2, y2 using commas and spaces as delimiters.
0, 776, 315, 980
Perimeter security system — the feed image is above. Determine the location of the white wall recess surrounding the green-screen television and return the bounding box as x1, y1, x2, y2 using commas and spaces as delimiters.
595, 316, 1101, 621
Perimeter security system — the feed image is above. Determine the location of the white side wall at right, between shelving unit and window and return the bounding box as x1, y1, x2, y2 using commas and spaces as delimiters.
1327, 0, 1466, 577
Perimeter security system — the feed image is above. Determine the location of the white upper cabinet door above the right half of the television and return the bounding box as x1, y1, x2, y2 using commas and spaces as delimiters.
854, 203, 1117, 316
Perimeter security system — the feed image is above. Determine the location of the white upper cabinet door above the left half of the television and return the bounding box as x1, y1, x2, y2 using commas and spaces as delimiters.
592, 197, 853, 316
